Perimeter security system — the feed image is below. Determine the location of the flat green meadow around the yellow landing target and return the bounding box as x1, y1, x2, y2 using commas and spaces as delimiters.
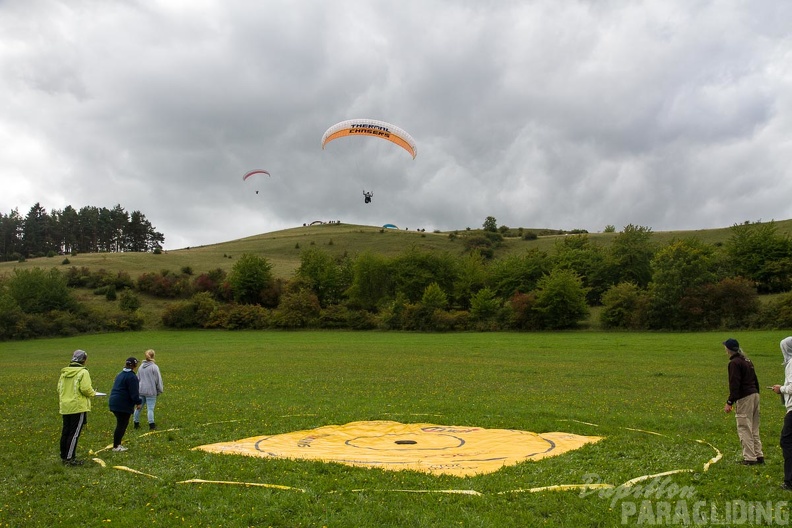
0, 331, 792, 527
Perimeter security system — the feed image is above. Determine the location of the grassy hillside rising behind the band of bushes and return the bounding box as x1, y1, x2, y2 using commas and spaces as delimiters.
0, 220, 792, 279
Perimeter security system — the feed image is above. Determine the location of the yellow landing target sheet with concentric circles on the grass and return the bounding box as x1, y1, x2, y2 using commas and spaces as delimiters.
195, 421, 601, 477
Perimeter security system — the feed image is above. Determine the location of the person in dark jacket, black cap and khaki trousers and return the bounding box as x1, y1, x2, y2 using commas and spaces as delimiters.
723, 339, 764, 466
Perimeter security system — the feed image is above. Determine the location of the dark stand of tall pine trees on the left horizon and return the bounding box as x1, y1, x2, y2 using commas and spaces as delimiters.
0, 203, 165, 261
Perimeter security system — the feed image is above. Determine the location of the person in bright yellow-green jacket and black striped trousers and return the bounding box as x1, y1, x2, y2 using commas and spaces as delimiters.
58, 350, 96, 466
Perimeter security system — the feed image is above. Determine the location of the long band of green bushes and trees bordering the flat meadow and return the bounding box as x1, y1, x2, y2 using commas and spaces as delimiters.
0, 222, 792, 339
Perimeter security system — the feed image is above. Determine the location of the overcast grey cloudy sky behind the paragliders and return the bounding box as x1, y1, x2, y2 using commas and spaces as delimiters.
0, 0, 792, 249
